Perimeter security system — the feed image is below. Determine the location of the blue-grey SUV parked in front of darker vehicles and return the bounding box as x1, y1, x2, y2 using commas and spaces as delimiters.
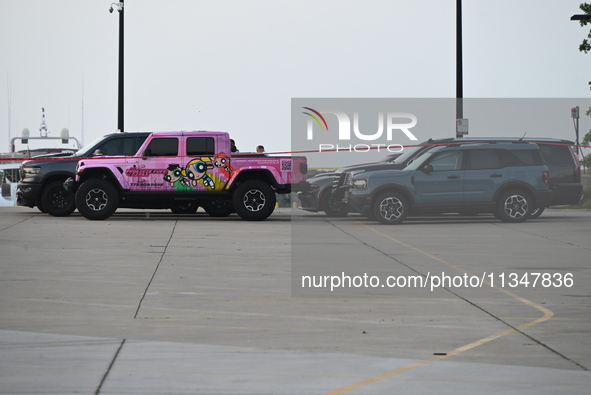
338, 141, 552, 224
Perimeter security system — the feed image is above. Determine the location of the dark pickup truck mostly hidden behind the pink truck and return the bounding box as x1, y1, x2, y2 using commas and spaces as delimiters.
16, 132, 150, 217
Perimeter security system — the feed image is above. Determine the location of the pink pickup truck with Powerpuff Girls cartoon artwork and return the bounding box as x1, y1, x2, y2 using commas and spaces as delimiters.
66, 131, 307, 221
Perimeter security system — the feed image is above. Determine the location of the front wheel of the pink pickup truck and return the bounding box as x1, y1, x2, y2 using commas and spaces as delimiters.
76, 179, 119, 220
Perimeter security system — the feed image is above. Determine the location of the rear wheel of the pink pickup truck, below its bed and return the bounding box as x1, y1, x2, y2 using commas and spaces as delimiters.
232, 180, 276, 221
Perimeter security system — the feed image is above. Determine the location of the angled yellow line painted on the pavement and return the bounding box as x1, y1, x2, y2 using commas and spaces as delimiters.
325, 224, 554, 395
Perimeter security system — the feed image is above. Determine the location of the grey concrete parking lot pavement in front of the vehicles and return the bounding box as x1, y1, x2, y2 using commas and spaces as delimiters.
0, 207, 591, 394
